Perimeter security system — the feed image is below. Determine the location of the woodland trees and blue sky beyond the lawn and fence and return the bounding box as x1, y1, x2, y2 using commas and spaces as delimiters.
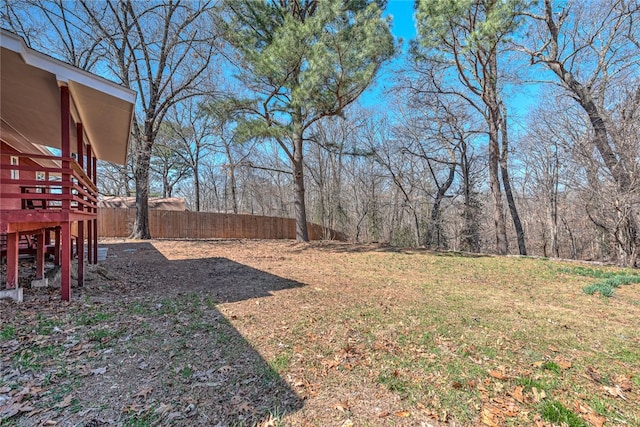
2, 0, 640, 266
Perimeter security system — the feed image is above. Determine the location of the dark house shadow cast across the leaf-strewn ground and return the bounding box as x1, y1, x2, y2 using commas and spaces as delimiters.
0, 242, 304, 426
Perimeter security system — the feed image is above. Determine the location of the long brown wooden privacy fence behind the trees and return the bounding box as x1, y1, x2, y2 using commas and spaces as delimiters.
98, 208, 346, 240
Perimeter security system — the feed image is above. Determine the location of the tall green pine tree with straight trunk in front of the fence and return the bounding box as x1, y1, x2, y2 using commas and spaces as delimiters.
218, 0, 395, 241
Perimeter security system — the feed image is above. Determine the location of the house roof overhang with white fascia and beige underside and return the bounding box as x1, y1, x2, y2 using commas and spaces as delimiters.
0, 30, 136, 164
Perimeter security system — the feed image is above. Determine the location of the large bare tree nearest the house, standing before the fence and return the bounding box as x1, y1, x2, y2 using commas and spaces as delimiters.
77, 0, 214, 239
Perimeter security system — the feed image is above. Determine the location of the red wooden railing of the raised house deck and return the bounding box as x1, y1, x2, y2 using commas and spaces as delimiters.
0, 151, 98, 215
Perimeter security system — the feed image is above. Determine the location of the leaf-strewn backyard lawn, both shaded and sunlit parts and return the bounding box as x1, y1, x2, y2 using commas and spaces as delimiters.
0, 241, 640, 426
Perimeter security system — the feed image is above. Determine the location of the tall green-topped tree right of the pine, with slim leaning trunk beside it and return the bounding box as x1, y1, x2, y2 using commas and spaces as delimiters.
413, 0, 526, 255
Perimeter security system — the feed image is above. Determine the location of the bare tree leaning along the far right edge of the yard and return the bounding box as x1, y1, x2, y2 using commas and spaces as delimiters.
520, 0, 640, 265
